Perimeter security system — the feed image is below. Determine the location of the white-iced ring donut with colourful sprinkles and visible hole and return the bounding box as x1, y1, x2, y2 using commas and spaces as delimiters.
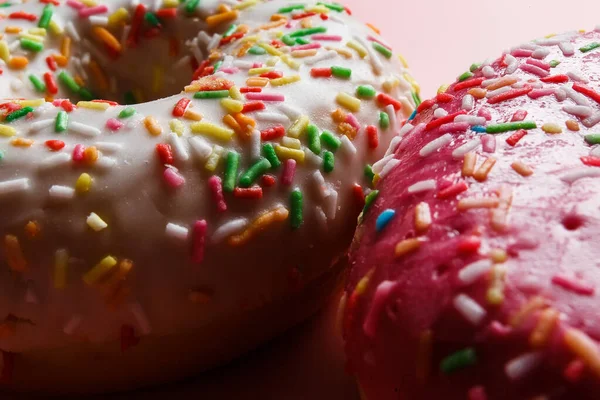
0, 0, 420, 393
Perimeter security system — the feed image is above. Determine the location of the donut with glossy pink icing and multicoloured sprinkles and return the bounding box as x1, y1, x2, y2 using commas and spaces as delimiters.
340, 26, 600, 400
